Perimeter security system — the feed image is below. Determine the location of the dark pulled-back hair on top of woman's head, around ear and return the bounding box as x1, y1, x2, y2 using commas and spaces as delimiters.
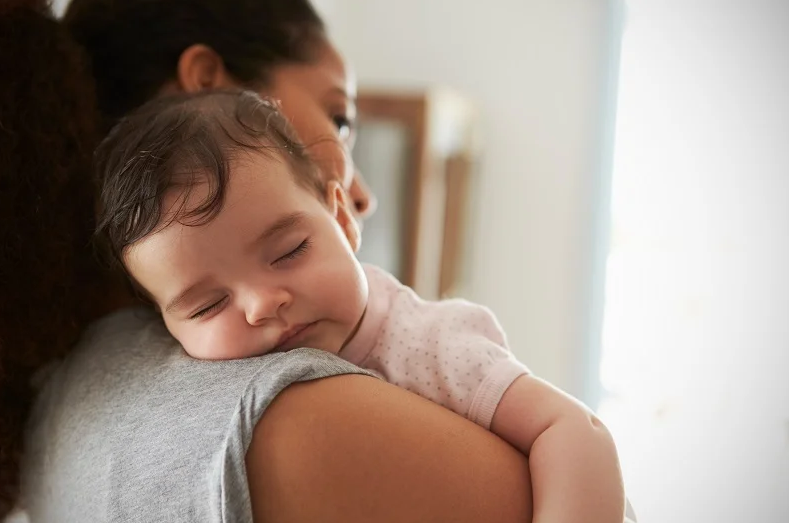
63, 0, 325, 128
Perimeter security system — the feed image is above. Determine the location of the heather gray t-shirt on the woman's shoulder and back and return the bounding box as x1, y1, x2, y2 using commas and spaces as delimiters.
22, 309, 372, 523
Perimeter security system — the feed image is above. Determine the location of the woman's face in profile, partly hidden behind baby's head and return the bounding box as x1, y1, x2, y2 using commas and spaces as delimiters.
261, 43, 376, 218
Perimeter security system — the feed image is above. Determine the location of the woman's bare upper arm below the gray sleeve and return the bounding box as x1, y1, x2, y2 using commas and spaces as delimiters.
247, 376, 531, 523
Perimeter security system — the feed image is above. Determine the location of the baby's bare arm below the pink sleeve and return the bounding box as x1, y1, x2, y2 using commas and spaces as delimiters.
490, 375, 625, 523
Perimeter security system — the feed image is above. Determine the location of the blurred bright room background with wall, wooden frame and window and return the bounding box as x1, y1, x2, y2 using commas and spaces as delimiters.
316, 0, 789, 523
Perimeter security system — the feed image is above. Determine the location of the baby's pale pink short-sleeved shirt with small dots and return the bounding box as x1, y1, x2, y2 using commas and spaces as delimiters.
340, 265, 528, 429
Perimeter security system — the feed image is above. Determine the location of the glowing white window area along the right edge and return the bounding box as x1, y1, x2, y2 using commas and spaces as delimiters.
601, 0, 789, 523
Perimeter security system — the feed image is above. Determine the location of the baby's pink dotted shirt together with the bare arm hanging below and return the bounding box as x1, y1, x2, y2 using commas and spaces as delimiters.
348, 266, 625, 523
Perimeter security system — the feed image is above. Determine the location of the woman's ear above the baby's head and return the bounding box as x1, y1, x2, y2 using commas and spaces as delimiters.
177, 44, 236, 93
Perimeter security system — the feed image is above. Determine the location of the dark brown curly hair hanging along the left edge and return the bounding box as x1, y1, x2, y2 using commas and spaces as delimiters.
0, 0, 106, 519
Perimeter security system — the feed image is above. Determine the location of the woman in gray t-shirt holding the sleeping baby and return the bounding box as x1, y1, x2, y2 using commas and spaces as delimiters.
0, 0, 530, 522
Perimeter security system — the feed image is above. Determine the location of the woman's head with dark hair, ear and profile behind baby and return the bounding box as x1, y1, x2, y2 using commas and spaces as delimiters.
64, 0, 375, 217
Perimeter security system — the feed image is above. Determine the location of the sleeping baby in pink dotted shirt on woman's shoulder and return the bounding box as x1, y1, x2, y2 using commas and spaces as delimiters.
96, 92, 625, 523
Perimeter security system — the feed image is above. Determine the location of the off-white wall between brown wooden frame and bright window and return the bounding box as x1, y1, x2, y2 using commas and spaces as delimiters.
316, 0, 610, 394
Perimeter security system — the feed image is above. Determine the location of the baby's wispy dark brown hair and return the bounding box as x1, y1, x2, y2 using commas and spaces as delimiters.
95, 91, 325, 267
